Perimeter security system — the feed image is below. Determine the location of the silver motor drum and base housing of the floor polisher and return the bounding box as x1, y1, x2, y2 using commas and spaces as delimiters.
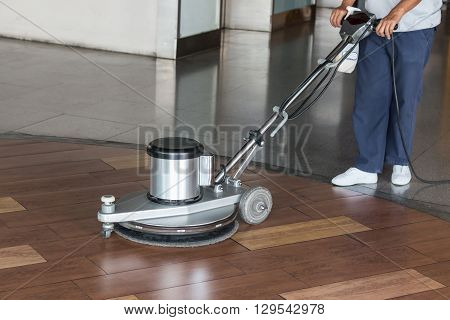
98, 137, 260, 237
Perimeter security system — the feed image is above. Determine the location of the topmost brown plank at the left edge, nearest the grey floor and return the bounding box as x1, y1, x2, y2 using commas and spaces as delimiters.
0, 142, 82, 158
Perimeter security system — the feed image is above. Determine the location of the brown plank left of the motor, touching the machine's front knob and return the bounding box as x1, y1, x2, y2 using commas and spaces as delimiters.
16, 183, 145, 209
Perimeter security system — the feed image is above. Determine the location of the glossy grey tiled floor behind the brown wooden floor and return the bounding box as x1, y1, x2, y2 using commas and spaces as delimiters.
0, 9, 450, 213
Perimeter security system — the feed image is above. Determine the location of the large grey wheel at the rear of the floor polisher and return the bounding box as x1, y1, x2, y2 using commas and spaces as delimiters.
239, 187, 273, 225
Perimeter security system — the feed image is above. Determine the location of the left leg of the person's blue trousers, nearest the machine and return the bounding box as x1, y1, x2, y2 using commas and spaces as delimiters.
353, 33, 392, 173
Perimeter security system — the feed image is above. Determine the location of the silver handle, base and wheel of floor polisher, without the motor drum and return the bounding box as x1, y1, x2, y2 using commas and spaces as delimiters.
98, 8, 379, 238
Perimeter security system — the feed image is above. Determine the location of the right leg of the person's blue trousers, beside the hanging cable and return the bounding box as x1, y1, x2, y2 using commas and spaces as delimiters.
385, 29, 435, 166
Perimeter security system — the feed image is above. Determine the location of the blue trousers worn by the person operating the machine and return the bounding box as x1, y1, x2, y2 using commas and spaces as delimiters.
353, 28, 435, 173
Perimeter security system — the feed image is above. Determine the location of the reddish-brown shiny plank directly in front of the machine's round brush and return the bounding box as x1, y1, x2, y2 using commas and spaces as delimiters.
88, 240, 247, 273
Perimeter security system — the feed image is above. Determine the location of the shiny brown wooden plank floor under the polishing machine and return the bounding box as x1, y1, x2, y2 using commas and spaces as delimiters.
0, 139, 450, 299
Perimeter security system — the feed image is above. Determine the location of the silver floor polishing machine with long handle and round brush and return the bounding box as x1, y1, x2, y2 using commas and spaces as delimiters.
98, 8, 386, 247
